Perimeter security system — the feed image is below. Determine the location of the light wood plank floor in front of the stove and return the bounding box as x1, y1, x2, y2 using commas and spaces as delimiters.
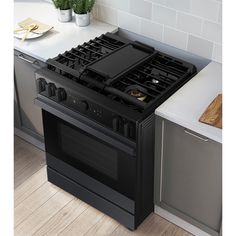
14, 138, 191, 236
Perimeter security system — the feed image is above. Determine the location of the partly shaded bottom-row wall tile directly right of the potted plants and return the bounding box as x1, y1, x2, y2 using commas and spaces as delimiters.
97, 5, 118, 25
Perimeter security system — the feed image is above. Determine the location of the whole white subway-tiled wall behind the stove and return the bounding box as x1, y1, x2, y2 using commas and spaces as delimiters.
94, 0, 222, 62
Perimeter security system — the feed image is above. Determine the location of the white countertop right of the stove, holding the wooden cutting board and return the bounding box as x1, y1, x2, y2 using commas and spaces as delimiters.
155, 62, 222, 143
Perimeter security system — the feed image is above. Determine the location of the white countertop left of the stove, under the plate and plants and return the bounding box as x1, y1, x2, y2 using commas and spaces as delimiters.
14, 1, 118, 62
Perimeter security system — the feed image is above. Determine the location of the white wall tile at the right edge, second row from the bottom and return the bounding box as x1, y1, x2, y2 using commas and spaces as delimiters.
202, 21, 222, 43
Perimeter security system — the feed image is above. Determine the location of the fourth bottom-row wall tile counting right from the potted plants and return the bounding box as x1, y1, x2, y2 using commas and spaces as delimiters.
163, 26, 188, 50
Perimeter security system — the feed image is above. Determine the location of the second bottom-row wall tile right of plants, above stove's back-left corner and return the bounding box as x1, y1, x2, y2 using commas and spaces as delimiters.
118, 11, 141, 33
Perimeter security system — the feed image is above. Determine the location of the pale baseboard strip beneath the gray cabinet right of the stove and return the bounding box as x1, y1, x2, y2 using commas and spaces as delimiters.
154, 206, 211, 236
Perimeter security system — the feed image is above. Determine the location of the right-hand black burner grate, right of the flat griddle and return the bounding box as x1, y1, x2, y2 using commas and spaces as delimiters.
112, 52, 196, 110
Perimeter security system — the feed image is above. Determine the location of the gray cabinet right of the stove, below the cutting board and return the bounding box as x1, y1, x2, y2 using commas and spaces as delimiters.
155, 117, 222, 235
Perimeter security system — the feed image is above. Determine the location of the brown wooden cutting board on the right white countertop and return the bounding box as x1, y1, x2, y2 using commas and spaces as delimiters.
199, 94, 222, 129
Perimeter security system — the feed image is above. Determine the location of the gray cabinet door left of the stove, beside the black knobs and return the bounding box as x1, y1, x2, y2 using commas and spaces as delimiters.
14, 51, 43, 136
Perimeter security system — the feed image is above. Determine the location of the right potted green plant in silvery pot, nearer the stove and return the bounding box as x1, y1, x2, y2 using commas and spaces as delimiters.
72, 0, 95, 26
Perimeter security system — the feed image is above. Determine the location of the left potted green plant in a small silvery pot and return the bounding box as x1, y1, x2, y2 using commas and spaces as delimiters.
52, 0, 72, 22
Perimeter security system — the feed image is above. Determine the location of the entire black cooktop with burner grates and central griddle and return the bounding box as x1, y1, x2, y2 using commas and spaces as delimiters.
47, 34, 196, 112
